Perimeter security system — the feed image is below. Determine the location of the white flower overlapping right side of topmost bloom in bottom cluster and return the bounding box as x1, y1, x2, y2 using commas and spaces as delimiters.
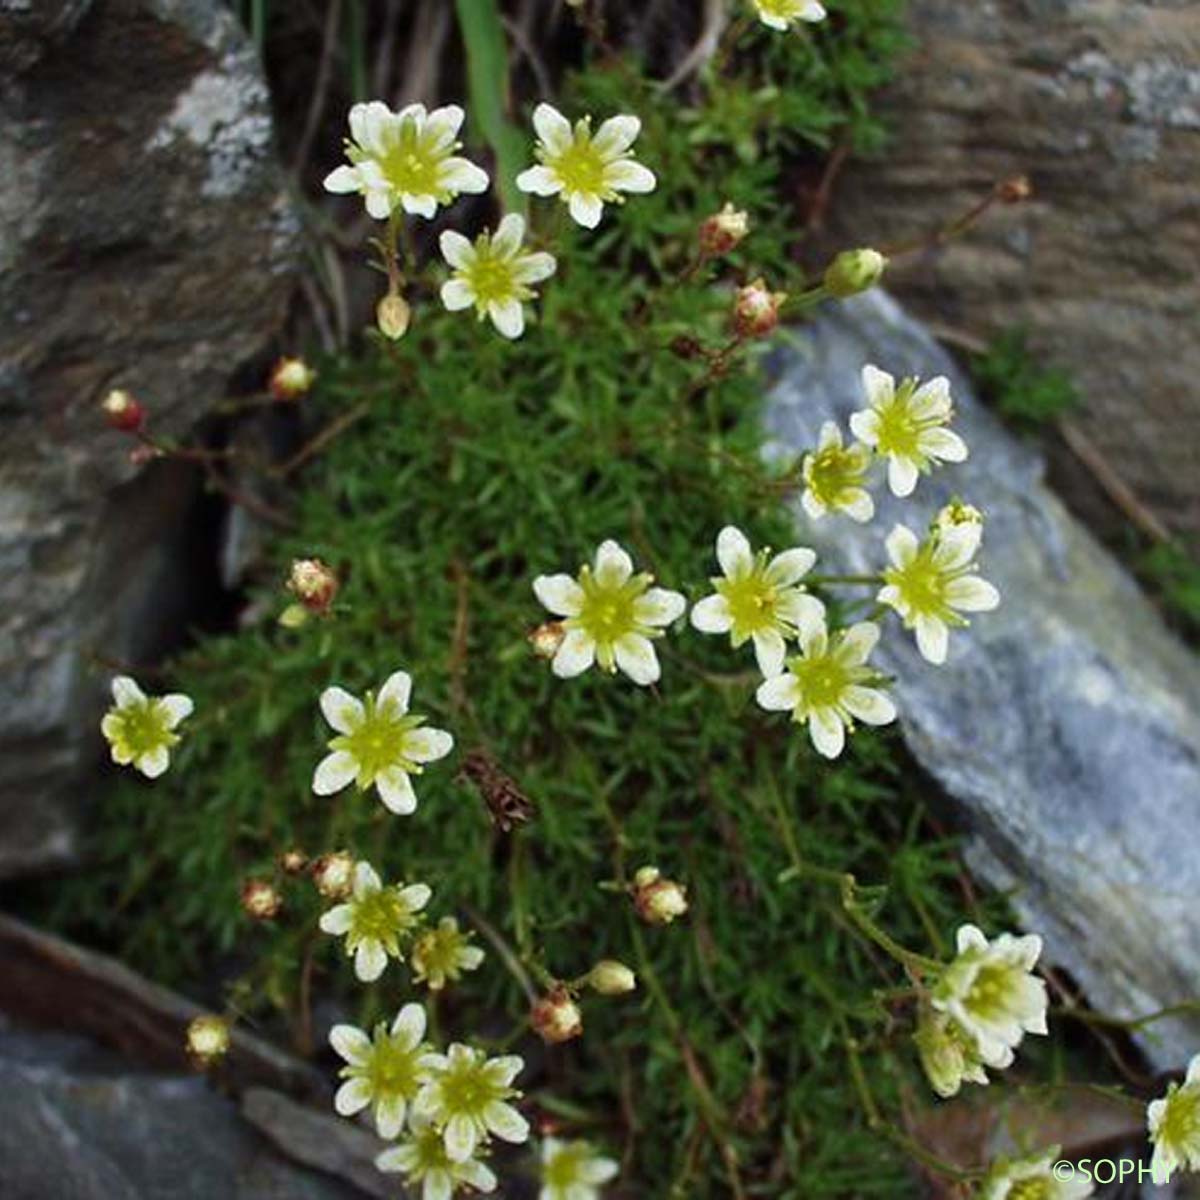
413, 1042, 529, 1163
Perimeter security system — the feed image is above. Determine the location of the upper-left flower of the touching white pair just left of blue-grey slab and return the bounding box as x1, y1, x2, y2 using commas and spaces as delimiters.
691, 526, 824, 676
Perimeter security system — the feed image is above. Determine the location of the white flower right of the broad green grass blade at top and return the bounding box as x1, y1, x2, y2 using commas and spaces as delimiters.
517, 104, 658, 229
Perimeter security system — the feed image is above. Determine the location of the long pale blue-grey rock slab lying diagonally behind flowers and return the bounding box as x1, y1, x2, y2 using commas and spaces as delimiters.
768, 293, 1200, 1067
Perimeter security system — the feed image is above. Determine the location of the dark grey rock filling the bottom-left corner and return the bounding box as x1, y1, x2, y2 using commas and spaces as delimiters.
0, 1027, 364, 1200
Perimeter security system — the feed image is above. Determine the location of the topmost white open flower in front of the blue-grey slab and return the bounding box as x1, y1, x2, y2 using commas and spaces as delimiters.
850, 366, 967, 496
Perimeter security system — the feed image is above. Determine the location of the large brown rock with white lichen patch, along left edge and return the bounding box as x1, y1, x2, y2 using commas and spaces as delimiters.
0, 0, 296, 876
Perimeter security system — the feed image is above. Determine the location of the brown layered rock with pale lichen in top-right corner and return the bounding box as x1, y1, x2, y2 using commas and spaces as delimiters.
833, 0, 1200, 534
